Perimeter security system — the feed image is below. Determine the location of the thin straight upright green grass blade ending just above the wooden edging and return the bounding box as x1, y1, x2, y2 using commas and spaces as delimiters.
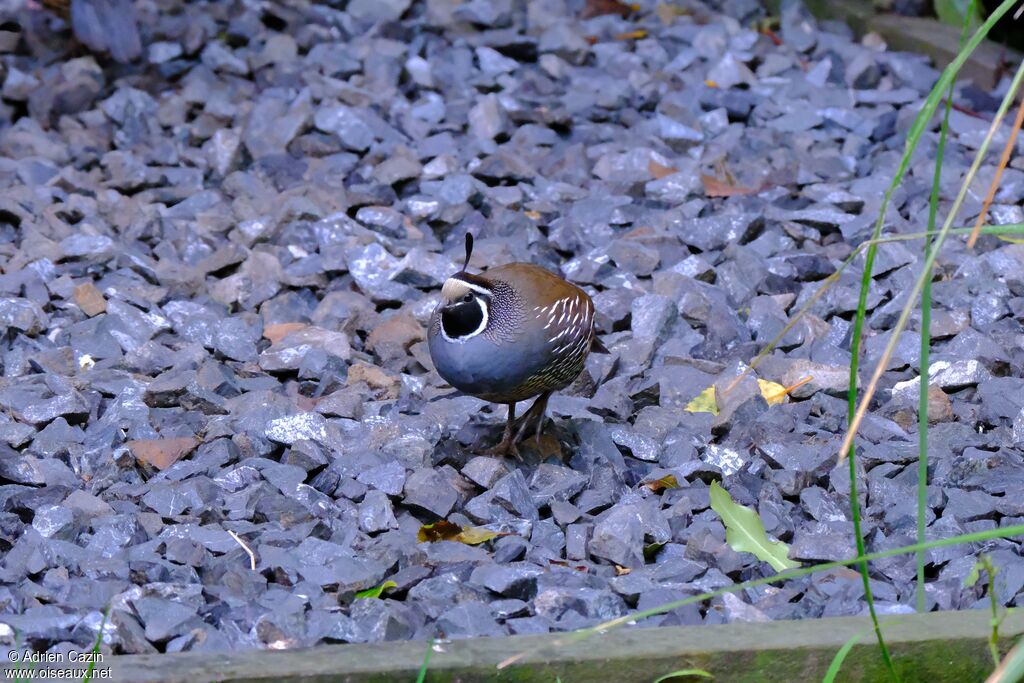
916, 0, 978, 612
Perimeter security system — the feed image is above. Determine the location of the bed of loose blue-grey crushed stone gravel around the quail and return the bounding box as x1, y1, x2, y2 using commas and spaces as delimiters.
0, 0, 1024, 653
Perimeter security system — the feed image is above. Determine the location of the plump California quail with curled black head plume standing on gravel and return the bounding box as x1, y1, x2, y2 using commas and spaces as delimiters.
427, 233, 596, 457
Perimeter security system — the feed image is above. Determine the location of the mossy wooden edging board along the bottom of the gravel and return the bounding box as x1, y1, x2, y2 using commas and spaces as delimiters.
6, 610, 1024, 683
